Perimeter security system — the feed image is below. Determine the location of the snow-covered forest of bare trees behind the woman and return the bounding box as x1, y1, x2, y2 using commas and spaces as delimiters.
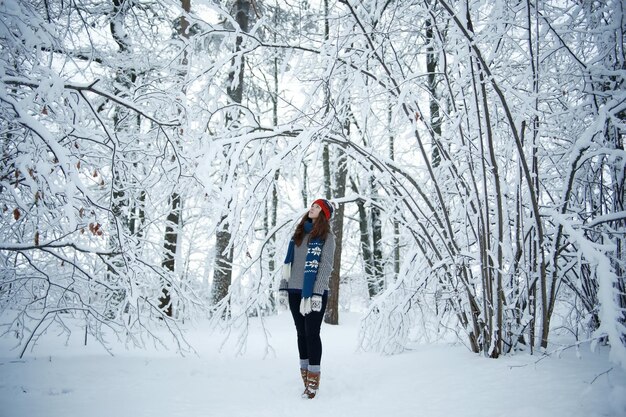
0, 0, 626, 367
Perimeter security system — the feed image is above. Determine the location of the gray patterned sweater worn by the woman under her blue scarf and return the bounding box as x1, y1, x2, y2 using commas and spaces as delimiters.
279, 231, 335, 295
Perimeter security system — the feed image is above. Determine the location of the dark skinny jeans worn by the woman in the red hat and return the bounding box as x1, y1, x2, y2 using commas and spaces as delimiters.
289, 293, 328, 365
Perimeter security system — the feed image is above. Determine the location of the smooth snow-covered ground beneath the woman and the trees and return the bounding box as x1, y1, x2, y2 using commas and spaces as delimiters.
0, 313, 626, 417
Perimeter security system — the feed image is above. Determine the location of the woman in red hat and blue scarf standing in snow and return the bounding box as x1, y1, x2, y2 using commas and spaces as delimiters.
280, 199, 335, 398
